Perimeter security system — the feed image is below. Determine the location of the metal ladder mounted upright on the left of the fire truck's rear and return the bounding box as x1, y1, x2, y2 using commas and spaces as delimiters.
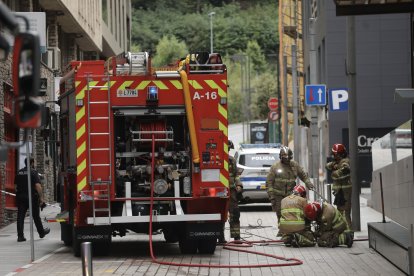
86, 76, 112, 225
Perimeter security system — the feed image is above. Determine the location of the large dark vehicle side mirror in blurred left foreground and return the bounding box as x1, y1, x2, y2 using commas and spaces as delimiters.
13, 33, 41, 128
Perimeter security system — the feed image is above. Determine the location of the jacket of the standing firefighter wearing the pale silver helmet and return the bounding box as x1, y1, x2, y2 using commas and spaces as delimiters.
266, 160, 313, 196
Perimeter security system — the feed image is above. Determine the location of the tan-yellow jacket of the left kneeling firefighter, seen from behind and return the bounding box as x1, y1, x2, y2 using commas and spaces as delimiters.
279, 195, 308, 234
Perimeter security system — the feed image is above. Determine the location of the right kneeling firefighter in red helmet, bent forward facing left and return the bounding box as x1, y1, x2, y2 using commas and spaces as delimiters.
305, 202, 354, 248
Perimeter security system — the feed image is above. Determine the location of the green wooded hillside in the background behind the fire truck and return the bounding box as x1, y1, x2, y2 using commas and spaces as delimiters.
132, 0, 279, 123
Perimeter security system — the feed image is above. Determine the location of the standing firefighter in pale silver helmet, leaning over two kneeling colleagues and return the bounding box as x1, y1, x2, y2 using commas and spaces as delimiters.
266, 146, 313, 227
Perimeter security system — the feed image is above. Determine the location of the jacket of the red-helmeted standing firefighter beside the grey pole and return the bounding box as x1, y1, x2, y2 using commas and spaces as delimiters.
325, 158, 352, 192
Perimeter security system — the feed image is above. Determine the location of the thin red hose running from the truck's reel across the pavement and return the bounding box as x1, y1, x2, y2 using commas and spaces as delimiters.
149, 134, 303, 268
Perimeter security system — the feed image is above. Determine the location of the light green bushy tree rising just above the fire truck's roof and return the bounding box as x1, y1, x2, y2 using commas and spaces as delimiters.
152, 35, 188, 67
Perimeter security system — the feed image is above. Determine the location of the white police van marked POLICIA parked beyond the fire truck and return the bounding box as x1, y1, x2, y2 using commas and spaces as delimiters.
234, 143, 281, 203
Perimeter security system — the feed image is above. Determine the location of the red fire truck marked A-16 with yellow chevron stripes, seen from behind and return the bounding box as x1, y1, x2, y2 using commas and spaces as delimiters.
59, 52, 229, 255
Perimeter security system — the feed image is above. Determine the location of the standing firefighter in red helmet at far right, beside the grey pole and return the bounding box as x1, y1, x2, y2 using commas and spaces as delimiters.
326, 144, 352, 227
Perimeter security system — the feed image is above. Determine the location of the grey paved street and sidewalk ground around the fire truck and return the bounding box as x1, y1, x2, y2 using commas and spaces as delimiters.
0, 191, 404, 276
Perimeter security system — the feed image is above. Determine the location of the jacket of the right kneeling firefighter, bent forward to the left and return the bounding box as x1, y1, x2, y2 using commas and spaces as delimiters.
316, 202, 347, 234
